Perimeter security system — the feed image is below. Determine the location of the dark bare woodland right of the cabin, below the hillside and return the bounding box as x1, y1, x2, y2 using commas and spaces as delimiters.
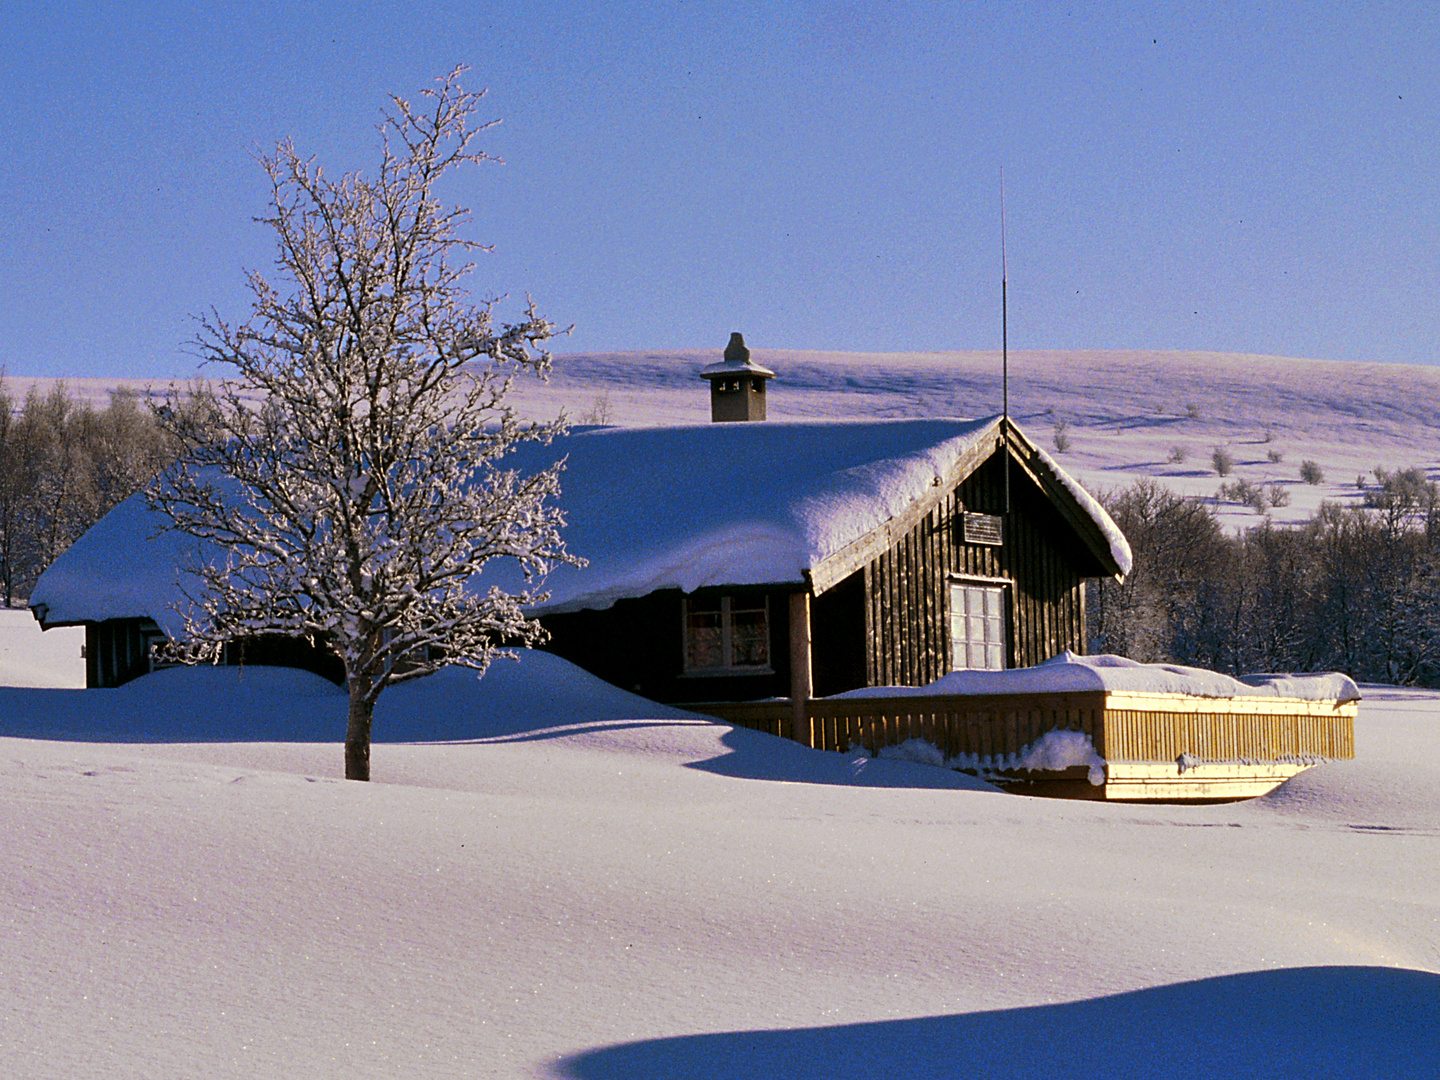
1087, 468, 1440, 685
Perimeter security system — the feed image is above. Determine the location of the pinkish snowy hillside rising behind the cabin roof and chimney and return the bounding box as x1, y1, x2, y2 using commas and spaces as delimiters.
7, 343, 1440, 528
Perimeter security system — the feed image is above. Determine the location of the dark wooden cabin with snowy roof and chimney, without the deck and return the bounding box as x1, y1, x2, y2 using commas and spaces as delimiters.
22, 368, 1129, 703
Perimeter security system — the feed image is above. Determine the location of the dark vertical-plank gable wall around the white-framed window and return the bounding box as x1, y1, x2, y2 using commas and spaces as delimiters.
864, 456, 1093, 685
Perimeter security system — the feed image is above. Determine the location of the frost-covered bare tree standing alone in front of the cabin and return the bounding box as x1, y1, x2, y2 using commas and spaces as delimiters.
150, 69, 580, 780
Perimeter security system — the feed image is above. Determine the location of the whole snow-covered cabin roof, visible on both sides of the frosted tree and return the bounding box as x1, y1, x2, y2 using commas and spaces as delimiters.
32, 418, 1130, 632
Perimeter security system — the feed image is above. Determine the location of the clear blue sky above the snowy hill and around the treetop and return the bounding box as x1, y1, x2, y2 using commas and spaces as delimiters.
0, 0, 1440, 376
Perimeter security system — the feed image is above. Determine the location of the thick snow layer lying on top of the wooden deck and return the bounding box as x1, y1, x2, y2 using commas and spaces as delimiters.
837, 652, 1359, 703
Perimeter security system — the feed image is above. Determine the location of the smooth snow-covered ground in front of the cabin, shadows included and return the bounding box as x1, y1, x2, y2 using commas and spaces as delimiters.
0, 655, 1440, 1080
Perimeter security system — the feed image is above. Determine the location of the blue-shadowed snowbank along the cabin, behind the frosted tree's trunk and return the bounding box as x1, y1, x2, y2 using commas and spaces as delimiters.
0, 652, 995, 791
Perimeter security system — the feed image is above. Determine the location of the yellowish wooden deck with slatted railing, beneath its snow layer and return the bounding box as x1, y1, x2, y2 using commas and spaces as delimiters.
687, 690, 1356, 802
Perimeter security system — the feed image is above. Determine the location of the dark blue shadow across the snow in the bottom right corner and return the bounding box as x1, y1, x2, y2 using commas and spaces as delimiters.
552, 968, 1440, 1080
